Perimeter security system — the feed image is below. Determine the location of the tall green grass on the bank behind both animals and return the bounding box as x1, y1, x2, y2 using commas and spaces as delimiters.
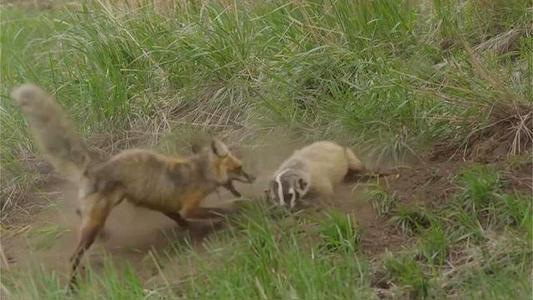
2, 0, 531, 164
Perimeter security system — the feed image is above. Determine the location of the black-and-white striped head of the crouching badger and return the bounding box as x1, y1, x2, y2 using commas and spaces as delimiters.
265, 169, 310, 209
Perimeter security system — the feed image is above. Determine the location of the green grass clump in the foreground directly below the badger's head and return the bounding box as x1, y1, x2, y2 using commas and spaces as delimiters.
186, 209, 370, 299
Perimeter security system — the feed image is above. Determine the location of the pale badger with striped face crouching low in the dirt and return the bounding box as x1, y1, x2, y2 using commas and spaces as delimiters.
265, 141, 366, 209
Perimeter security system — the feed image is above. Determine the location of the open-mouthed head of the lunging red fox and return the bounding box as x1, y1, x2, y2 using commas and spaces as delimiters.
192, 139, 255, 185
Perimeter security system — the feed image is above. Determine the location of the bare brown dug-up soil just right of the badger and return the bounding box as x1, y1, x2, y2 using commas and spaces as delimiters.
328, 157, 471, 257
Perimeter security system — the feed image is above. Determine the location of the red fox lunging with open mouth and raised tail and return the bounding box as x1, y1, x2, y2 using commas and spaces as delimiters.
12, 84, 255, 287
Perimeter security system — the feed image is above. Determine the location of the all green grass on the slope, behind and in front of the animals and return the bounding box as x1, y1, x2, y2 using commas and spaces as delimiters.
0, 0, 533, 299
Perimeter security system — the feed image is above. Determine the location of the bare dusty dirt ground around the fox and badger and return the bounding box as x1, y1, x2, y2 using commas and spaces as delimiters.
1, 143, 532, 288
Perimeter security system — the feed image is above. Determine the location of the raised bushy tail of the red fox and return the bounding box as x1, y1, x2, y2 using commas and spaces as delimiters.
11, 84, 91, 182
